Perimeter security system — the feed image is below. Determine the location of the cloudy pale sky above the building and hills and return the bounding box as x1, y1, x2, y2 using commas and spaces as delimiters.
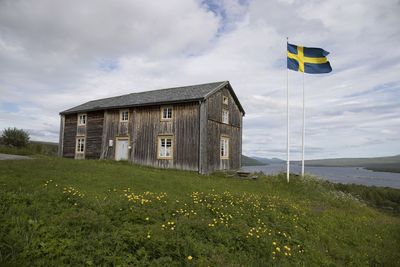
0, 0, 400, 159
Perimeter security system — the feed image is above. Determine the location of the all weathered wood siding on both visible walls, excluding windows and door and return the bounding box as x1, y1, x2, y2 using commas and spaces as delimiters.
60, 85, 243, 174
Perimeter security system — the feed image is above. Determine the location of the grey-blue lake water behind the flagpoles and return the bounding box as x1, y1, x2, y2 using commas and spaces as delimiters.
242, 163, 400, 189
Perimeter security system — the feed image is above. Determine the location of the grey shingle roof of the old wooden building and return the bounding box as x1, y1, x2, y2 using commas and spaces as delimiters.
60, 81, 243, 114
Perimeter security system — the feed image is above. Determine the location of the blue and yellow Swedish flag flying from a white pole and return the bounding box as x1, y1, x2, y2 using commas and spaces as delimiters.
287, 43, 332, 74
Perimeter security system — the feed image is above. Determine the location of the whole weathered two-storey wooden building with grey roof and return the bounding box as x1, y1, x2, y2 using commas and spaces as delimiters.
59, 81, 245, 174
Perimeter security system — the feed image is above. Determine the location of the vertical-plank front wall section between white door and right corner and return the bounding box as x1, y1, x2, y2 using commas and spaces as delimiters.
132, 103, 199, 171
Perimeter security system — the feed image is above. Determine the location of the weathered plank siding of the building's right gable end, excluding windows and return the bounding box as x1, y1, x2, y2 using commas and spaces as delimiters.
206, 88, 242, 172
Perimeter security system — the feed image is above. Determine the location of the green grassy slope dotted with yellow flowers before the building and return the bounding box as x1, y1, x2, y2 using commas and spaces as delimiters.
0, 157, 400, 266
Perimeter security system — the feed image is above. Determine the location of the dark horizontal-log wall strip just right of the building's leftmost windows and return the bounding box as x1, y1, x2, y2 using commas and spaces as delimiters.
85, 111, 104, 159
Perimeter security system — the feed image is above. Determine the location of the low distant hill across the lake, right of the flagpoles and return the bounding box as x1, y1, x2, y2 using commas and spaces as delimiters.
305, 155, 400, 172
